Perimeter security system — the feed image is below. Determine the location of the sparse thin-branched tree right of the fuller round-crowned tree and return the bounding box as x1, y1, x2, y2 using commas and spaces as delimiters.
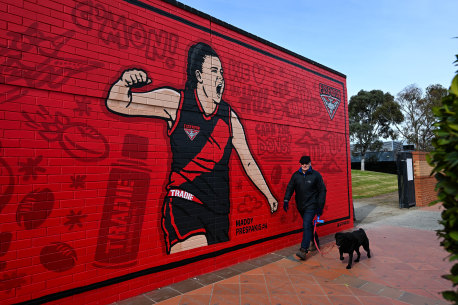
395, 85, 447, 151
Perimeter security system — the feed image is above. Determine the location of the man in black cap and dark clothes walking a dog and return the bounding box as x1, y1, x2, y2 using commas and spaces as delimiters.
283, 156, 326, 260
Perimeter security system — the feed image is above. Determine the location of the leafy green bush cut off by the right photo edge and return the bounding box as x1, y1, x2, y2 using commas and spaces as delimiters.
428, 55, 458, 304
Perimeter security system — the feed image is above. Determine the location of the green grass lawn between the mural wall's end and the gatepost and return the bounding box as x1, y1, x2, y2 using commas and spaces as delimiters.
351, 169, 398, 199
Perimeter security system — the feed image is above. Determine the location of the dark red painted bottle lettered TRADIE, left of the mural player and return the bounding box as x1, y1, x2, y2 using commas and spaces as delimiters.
94, 135, 150, 268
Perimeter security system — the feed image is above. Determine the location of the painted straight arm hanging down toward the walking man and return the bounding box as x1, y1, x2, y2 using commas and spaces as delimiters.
231, 111, 278, 213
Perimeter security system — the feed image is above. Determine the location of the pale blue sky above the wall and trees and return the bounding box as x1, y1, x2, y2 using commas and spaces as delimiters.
179, 0, 458, 99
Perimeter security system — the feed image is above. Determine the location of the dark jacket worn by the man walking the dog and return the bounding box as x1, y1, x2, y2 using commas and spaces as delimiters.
284, 168, 326, 215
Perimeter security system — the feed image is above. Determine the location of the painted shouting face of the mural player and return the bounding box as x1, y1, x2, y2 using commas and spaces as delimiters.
196, 56, 224, 104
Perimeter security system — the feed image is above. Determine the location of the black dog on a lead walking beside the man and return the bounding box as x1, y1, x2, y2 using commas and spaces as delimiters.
334, 229, 371, 269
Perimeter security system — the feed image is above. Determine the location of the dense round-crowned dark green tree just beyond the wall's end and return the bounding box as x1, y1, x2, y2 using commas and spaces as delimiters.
348, 90, 403, 170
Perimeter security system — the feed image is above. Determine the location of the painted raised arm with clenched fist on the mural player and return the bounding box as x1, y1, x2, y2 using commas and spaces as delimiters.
106, 69, 180, 126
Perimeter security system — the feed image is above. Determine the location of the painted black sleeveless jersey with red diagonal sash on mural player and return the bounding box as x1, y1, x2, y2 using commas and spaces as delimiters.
167, 91, 232, 214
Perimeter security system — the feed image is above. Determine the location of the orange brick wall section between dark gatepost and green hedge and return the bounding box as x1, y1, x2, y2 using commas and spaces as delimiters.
412, 151, 437, 206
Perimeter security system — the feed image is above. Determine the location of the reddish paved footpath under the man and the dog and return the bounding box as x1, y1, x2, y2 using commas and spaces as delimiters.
116, 192, 452, 305
